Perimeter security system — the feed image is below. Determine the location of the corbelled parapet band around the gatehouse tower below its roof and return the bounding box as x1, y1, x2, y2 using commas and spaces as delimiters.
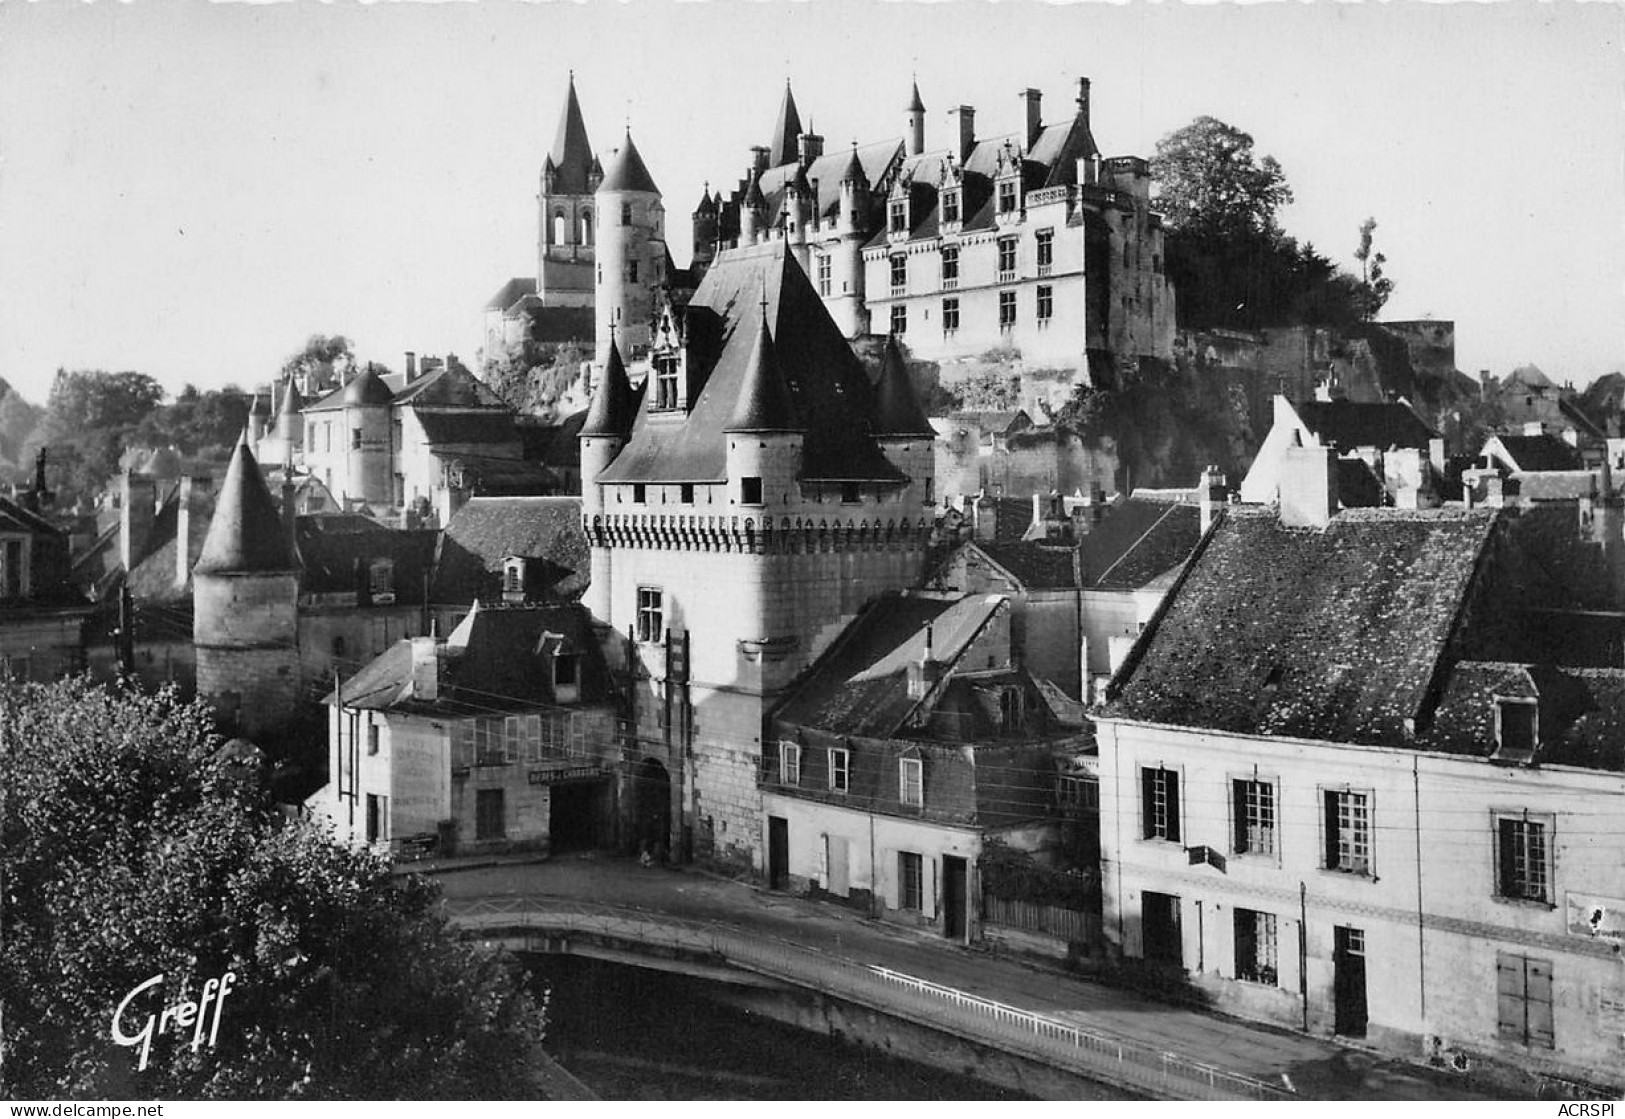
582, 513, 933, 555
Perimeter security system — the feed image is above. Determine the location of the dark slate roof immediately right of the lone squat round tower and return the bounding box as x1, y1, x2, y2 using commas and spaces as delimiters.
294, 513, 440, 606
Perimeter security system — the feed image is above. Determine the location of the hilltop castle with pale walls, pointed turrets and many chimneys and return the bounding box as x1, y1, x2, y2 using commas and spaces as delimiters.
484, 76, 1175, 382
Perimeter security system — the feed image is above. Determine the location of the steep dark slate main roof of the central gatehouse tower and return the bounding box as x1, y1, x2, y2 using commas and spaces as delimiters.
600, 240, 902, 482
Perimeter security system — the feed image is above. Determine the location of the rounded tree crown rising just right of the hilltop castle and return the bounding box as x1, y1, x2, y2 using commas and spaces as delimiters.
1151, 117, 1292, 240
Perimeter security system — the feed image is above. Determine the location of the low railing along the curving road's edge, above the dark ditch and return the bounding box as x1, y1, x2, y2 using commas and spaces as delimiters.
449, 896, 1290, 1100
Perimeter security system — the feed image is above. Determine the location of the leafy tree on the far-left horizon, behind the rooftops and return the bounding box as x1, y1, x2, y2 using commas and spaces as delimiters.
20, 369, 164, 500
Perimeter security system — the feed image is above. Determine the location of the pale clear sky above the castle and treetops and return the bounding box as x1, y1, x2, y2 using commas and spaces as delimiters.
0, 0, 1625, 403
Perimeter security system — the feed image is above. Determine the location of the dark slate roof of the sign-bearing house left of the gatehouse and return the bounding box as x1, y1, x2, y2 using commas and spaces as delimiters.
328, 606, 608, 718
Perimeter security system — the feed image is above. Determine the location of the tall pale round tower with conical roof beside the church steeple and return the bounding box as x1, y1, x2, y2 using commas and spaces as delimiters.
593, 130, 666, 362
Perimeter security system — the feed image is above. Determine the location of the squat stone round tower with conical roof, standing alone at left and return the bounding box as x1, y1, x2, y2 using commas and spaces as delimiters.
192, 440, 299, 737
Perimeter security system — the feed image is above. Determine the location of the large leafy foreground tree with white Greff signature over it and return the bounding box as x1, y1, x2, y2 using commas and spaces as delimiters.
0, 680, 544, 1100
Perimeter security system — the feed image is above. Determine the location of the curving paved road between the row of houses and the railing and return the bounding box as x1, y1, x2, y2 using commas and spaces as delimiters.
422, 856, 1489, 1100
